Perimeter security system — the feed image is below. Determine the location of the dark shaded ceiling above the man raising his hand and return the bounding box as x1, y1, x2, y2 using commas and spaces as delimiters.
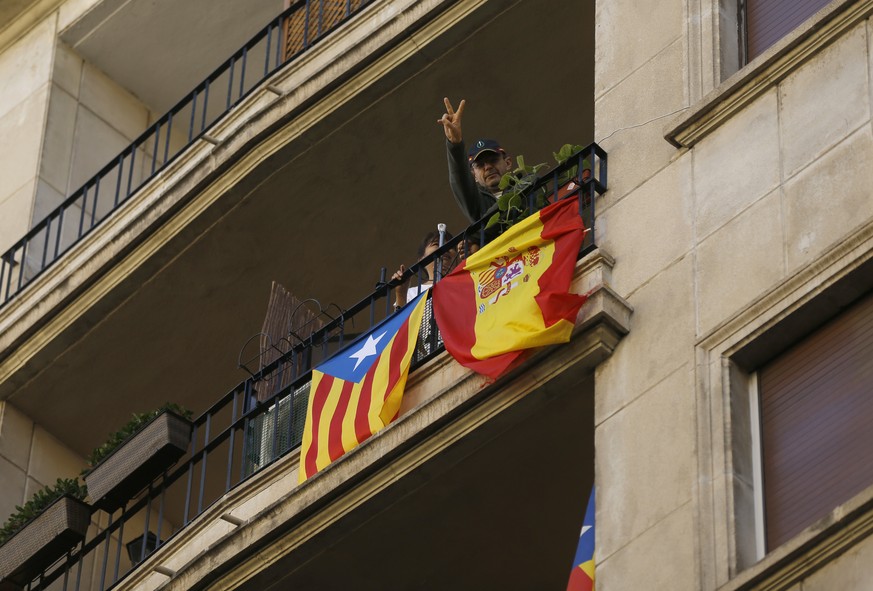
8, 0, 594, 454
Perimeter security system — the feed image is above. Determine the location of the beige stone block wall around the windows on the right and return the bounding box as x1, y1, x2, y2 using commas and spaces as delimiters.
595, 0, 873, 590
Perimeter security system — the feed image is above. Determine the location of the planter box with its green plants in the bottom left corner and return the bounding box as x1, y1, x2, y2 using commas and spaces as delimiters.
0, 478, 91, 589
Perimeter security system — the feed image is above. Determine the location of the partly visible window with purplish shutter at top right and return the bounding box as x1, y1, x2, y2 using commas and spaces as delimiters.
739, 0, 830, 64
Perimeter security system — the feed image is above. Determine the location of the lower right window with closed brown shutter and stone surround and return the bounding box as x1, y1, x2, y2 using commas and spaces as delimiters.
695, 243, 873, 589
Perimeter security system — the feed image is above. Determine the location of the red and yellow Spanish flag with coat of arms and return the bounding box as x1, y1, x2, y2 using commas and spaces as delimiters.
432, 199, 585, 378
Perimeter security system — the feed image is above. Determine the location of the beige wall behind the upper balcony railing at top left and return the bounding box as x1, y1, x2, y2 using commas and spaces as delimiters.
0, 0, 155, 262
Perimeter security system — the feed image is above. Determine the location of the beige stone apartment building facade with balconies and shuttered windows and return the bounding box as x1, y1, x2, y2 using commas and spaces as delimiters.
0, 0, 873, 591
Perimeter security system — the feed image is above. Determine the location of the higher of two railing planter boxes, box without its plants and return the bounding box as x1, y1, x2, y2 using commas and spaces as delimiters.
85, 411, 191, 512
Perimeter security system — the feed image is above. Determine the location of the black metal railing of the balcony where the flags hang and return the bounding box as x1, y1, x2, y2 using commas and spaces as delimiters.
20, 144, 607, 591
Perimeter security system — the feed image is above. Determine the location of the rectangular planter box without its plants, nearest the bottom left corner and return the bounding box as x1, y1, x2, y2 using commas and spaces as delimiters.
0, 495, 91, 591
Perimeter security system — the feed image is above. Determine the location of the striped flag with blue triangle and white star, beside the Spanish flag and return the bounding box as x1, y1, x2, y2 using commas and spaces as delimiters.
299, 292, 428, 482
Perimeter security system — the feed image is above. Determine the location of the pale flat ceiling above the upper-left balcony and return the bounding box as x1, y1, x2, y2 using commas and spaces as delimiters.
61, 0, 283, 113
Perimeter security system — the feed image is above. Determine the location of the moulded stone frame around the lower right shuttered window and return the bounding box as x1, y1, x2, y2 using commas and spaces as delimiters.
694, 230, 873, 591
